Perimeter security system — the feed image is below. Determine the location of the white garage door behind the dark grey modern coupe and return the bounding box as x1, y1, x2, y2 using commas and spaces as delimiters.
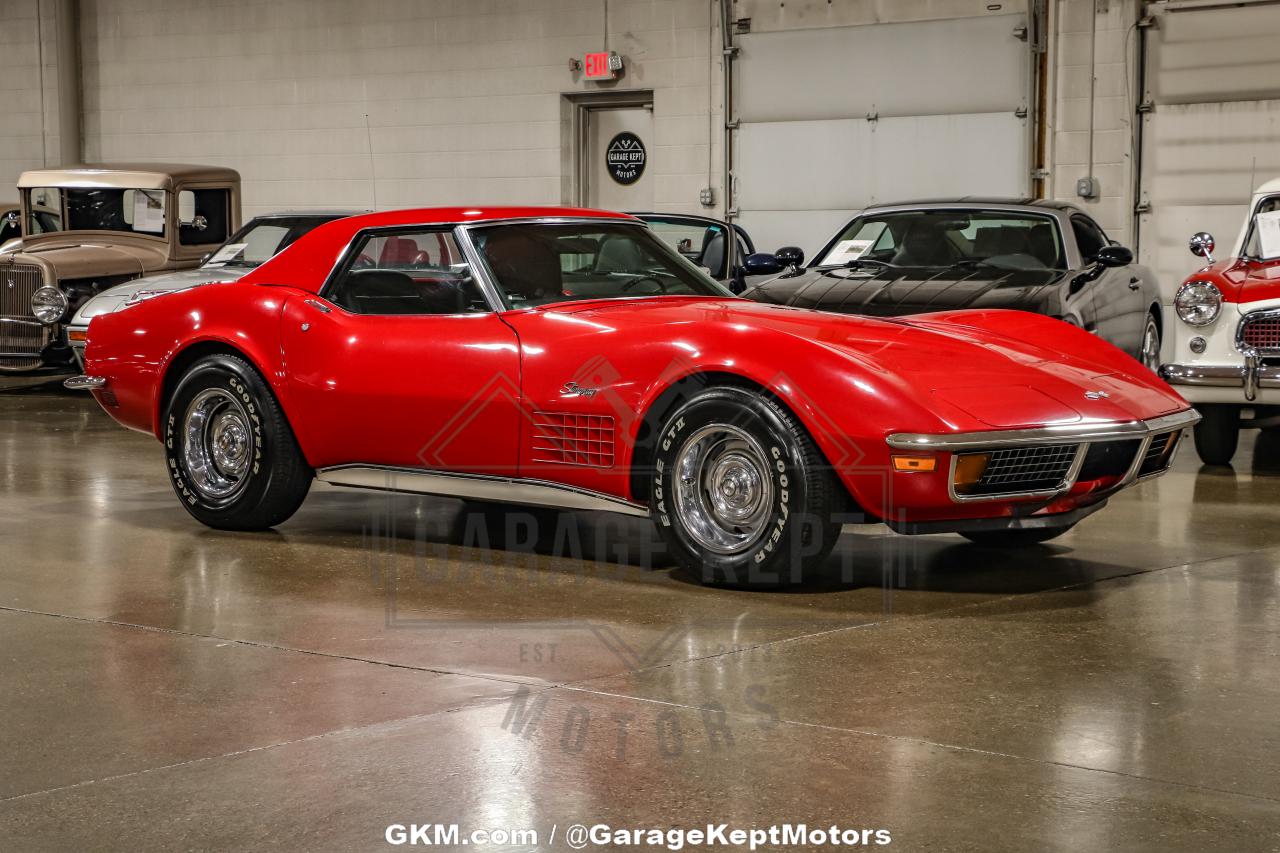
733, 10, 1030, 254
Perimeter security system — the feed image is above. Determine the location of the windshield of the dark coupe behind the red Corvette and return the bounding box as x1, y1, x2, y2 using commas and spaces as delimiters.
817, 210, 1066, 269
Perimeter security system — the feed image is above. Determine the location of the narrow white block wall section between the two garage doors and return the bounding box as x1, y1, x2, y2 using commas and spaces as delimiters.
1050, 0, 1139, 246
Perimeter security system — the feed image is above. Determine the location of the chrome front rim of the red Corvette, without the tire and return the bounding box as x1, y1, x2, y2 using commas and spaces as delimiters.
673, 424, 773, 555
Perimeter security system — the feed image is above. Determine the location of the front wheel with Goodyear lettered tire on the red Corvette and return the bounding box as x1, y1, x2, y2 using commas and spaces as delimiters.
650, 388, 842, 587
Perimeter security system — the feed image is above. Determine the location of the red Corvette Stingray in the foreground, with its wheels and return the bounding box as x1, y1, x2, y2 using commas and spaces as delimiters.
69, 207, 1197, 583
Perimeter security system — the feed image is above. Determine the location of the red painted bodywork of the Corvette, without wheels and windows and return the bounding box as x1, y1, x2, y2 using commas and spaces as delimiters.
86, 209, 1187, 521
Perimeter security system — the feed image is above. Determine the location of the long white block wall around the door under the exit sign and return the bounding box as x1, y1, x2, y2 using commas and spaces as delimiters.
74, 0, 723, 218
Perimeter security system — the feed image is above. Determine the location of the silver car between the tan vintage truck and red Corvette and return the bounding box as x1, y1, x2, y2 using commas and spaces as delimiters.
67, 210, 360, 362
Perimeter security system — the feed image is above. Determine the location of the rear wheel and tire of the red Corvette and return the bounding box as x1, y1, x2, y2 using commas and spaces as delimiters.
164, 355, 314, 530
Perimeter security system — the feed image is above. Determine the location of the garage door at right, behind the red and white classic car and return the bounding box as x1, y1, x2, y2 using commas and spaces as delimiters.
1138, 1, 1280, 302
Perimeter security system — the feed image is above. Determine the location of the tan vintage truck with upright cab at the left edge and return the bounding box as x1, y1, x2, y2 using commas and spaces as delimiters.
0, 163, 241, 374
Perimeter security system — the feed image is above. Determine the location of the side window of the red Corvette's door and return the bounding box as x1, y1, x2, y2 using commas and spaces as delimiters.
329, 231, 489, 315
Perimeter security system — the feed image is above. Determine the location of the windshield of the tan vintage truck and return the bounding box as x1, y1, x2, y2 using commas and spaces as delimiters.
27, 187, 166, 237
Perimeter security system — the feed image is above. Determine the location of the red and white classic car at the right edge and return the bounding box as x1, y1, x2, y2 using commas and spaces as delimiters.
1160, 179, 1280, 465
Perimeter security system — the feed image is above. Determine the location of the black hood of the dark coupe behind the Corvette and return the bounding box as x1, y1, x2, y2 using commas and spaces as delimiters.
742, 266, 1068, 316
